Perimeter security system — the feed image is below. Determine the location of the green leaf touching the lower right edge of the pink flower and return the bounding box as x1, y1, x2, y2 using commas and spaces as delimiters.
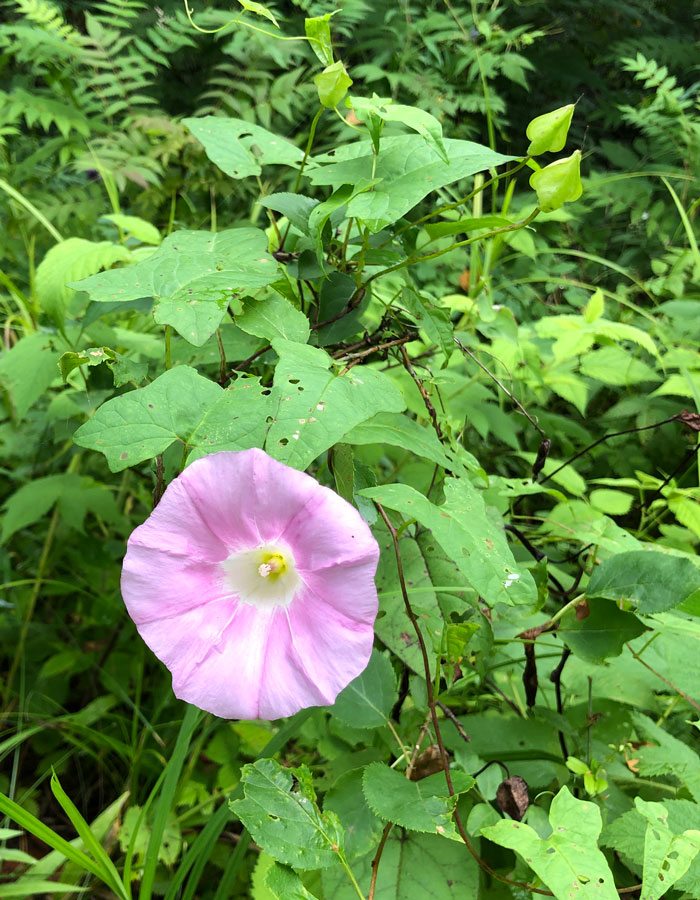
329, 650, 396, 728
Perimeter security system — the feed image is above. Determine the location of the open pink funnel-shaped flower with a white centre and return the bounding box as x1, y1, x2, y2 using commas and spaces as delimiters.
122, 450, 379, 719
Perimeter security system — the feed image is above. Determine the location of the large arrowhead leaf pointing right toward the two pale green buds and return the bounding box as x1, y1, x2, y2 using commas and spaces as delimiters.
307, 135, 515, 232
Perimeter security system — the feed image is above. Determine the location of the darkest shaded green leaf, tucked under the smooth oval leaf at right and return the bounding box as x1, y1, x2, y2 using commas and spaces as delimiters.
557, 600, 646, 663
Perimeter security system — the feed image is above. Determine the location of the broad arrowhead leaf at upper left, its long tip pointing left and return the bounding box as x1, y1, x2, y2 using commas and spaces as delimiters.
72, 228, 279, 347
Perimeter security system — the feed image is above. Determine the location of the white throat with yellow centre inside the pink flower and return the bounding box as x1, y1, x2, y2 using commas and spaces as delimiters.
221, 544, 301, 609
